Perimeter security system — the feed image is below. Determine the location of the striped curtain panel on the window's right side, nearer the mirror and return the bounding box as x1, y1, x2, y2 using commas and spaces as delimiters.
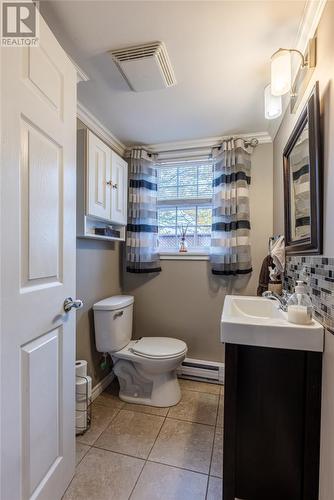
210, 139, 252, 276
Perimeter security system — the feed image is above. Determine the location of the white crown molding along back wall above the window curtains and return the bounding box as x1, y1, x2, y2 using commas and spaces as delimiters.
145, 132, 272, 153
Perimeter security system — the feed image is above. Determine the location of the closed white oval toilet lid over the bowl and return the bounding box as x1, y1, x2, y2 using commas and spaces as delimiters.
132, 337, 187, 358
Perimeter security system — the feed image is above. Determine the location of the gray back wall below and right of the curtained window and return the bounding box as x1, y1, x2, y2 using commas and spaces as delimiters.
123, 144, 273, 361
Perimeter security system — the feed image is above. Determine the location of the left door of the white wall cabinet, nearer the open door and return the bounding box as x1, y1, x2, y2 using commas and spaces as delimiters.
86, 130, 112, 220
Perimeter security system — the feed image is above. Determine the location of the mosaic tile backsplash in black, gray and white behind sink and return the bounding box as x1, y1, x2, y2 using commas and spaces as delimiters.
285, 255, 334, 335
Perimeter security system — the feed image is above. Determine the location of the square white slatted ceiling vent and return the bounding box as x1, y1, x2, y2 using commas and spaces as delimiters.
109, 42, 176, 92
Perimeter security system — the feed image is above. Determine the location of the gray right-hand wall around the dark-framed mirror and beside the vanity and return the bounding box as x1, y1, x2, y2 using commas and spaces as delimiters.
274, 2, 334, 500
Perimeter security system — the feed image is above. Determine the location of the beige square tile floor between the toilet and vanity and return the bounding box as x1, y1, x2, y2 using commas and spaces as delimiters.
63, 380, 223, 500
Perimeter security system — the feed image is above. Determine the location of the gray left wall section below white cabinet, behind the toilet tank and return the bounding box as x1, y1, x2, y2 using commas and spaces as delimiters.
77, 234, 121, 387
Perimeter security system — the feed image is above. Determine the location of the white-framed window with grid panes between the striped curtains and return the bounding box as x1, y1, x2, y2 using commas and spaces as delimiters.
158, 162, 212, 252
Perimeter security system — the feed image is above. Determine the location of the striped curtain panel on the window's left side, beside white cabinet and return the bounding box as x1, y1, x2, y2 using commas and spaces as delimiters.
126, 148, 161, 273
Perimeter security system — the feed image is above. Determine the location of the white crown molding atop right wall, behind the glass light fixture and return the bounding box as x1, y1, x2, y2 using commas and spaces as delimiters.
268, 0, 327, 139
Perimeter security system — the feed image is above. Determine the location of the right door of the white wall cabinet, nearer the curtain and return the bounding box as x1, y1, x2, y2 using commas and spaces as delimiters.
110, 151, 128, 226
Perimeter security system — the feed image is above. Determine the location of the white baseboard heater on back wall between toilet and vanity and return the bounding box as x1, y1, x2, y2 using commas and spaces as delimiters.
177, 358, 224, 384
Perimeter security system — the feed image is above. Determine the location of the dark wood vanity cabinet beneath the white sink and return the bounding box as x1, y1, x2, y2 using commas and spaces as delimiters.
223, 344, 322, 500
